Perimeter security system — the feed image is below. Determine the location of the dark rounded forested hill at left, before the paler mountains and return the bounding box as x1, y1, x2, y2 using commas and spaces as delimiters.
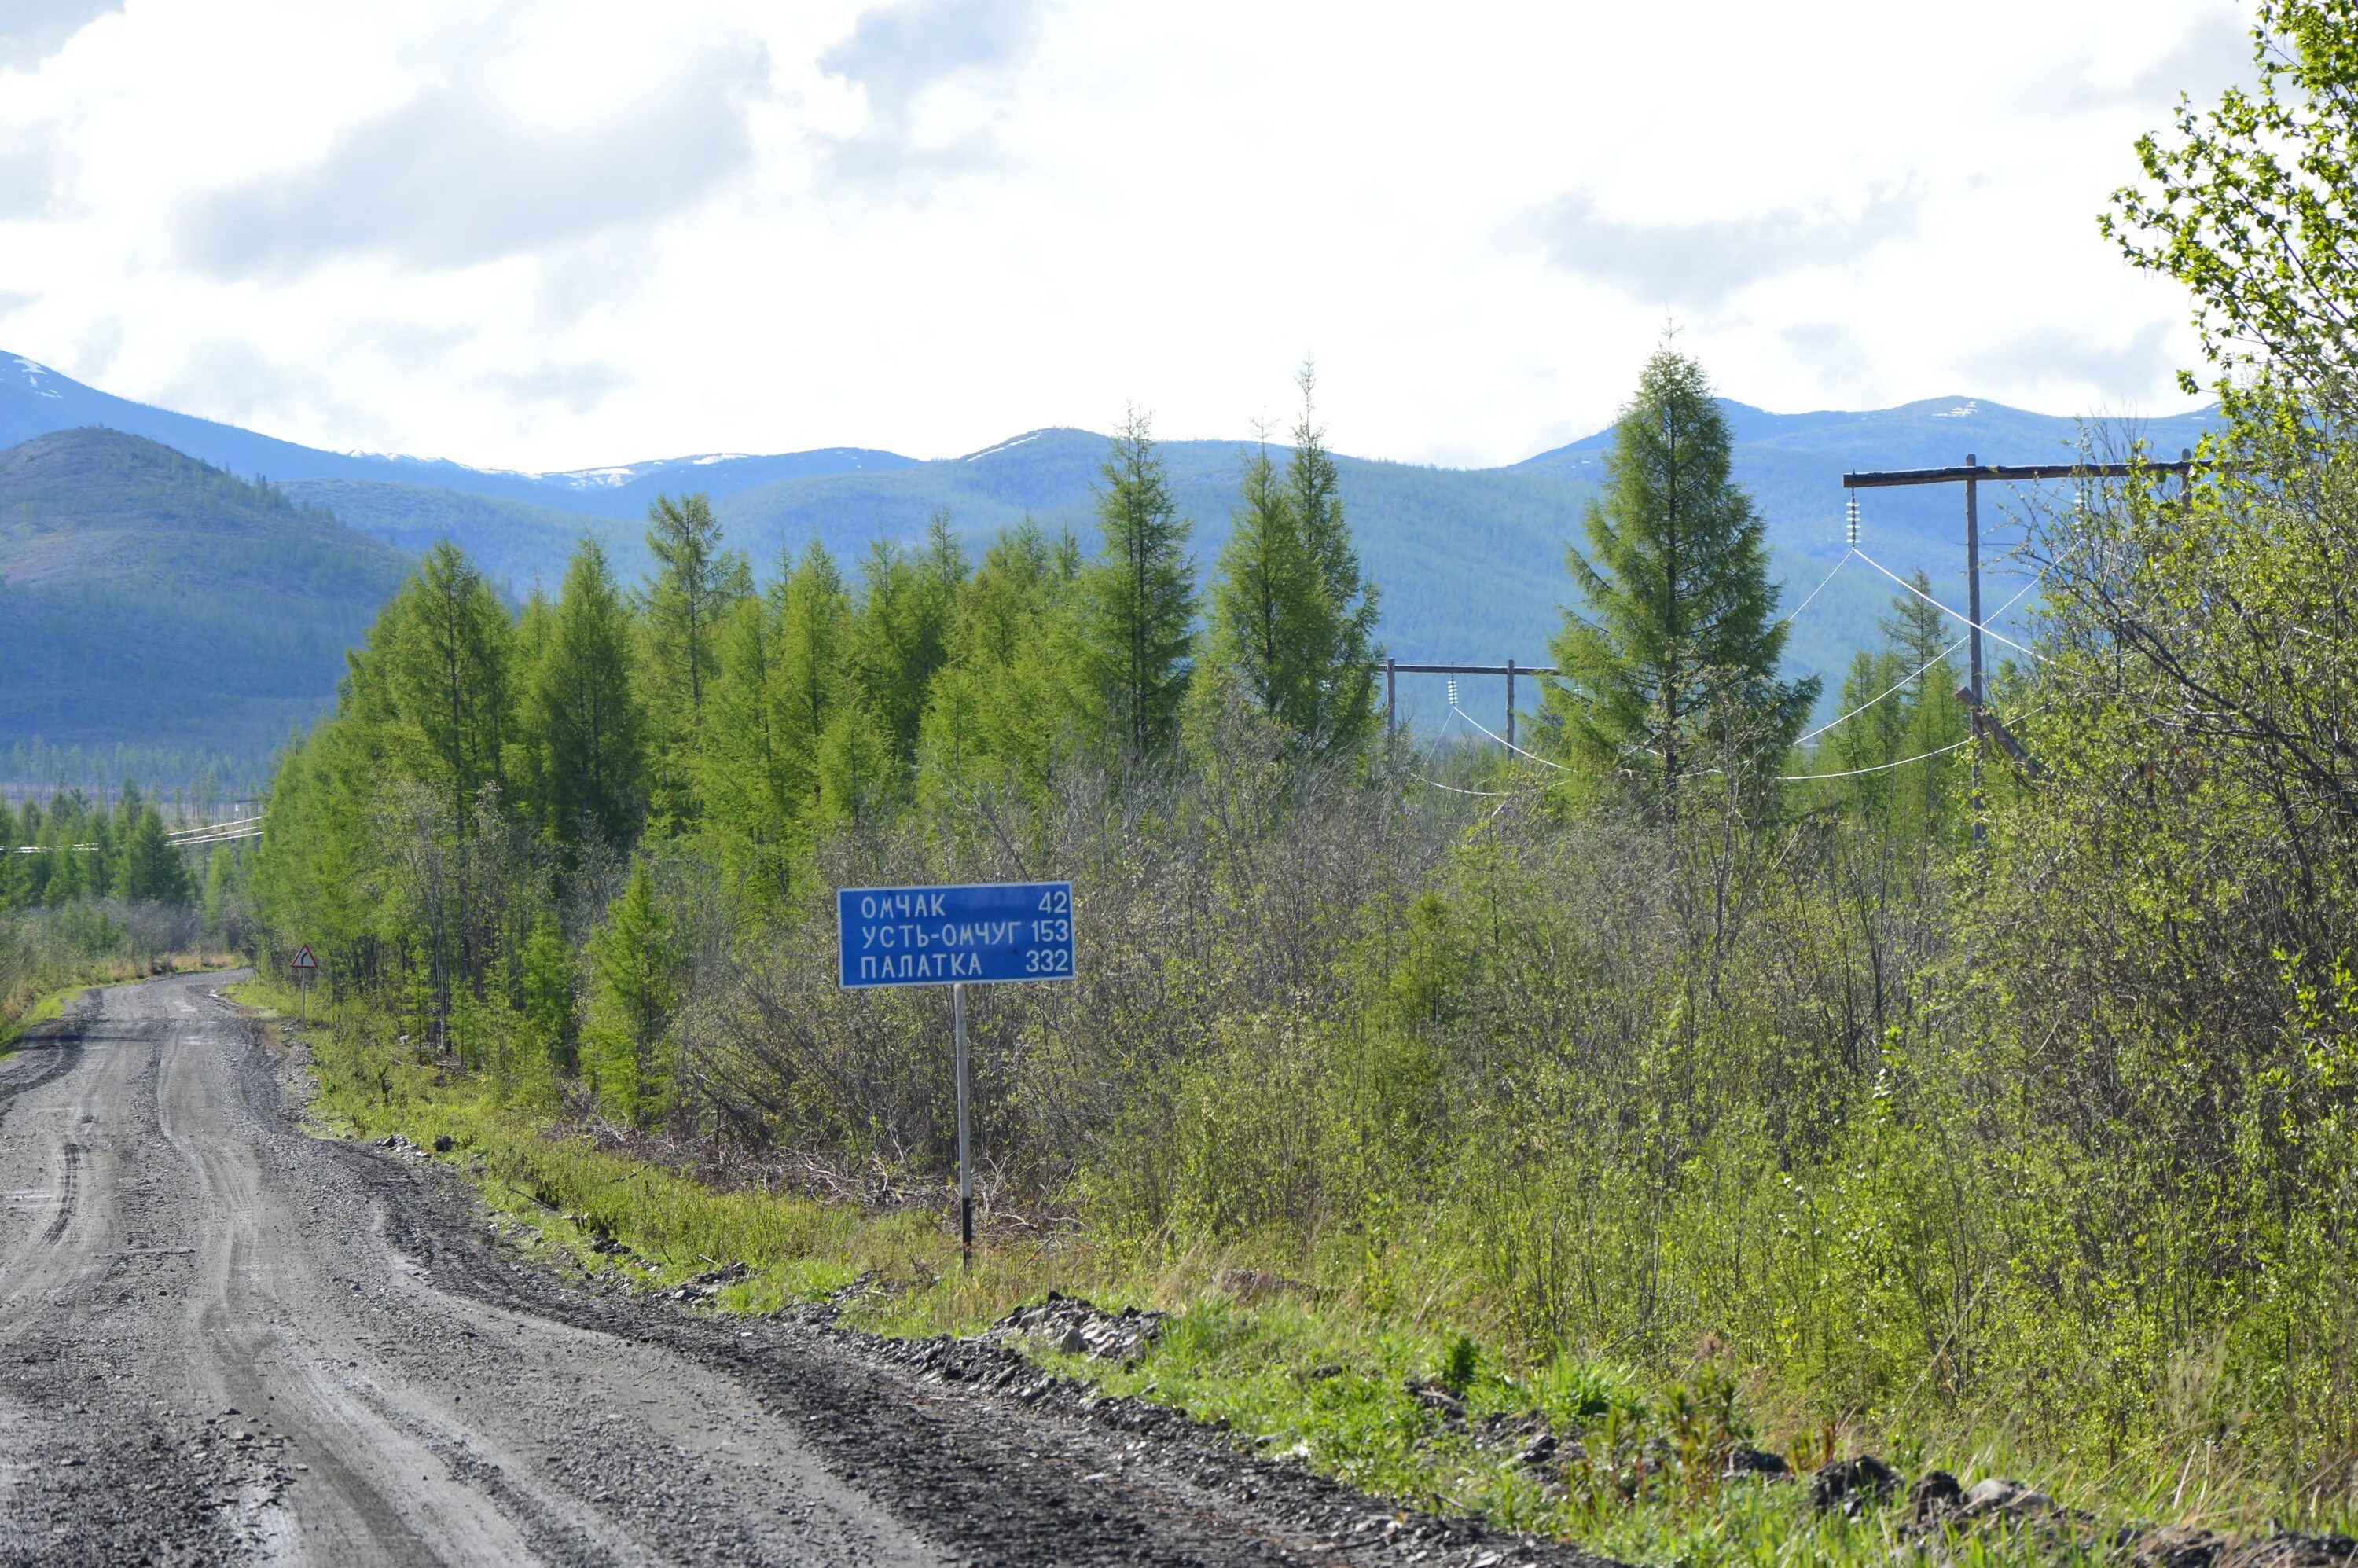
0, 429, 410, 755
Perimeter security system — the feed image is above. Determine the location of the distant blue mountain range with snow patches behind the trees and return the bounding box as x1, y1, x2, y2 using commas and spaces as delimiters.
0, 356, 2214, 745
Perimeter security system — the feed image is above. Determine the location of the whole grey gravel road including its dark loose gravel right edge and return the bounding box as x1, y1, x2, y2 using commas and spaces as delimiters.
0, 976, 1592, 1566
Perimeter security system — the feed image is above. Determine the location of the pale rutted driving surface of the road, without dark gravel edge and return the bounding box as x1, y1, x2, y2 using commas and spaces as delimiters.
0, 979, 938, 1568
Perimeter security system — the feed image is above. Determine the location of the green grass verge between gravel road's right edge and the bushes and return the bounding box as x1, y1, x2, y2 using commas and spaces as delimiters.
226, 979, 2353, 1568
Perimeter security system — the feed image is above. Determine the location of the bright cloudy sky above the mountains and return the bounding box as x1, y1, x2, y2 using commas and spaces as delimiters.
0, 0, 2247, 469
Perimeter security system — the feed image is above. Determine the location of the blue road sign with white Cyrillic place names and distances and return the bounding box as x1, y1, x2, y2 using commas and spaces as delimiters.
835, 882, 1075, 990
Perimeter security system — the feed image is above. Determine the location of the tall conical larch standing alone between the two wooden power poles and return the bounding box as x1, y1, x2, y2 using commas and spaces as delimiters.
1540, 347, 1818, 818
